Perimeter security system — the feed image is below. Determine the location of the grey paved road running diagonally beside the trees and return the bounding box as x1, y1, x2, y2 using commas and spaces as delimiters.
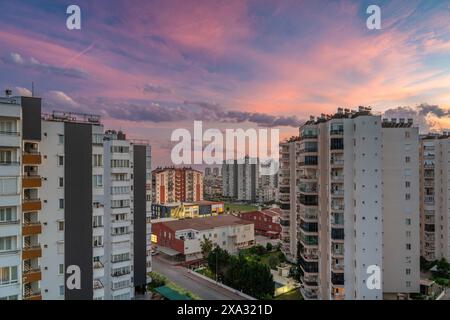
152, 256, 246, 300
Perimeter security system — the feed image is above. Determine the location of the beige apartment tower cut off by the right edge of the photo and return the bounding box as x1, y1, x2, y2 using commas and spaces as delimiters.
420, 131, 450, 261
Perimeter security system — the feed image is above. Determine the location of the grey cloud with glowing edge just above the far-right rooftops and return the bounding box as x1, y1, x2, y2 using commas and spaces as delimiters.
383, 103, 450, 133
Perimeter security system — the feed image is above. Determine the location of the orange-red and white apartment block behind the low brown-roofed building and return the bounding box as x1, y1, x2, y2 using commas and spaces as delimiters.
152, 167, 203, 204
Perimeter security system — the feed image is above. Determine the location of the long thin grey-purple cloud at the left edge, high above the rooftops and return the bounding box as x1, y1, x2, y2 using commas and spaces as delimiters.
2, 52, 88, 79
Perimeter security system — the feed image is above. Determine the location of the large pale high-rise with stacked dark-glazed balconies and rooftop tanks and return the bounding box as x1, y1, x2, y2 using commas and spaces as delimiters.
280, 107, 420, 300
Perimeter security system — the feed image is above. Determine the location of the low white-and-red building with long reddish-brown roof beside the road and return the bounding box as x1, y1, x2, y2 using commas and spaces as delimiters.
152, 214, 255, 262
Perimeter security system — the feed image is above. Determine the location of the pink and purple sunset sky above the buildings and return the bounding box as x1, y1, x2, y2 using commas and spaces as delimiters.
0, 0, 450, 166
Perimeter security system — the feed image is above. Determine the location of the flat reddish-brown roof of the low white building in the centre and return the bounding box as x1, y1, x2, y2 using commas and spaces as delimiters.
159, 214, 253, 231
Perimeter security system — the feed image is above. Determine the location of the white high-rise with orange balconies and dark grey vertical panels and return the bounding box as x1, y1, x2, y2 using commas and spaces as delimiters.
0, 93, 151, 299
